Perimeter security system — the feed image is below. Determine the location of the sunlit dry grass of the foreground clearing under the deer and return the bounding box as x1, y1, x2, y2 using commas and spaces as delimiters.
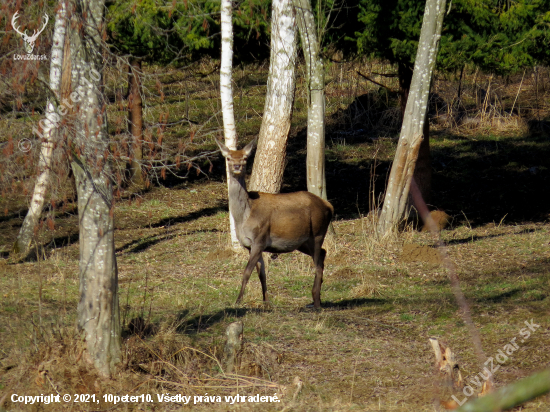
0, 182, 550, 411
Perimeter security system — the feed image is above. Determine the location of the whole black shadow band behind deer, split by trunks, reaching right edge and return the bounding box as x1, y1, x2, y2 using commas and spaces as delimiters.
283, 96, 550, 227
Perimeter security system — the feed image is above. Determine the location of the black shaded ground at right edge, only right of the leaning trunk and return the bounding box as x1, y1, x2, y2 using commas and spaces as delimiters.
432, 135, 550, 225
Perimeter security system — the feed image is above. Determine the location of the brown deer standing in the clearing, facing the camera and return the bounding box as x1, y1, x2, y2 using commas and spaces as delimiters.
216, 139, 334, 309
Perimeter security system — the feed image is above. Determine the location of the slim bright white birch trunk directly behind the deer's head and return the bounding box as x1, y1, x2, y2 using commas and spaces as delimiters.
220, 0, 241, 251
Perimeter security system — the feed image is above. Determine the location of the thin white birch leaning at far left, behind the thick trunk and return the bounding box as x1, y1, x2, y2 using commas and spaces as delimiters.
13, 2, 67, 255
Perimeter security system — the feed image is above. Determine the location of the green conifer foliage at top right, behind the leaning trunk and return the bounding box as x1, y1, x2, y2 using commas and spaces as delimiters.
354, 0, 550, 75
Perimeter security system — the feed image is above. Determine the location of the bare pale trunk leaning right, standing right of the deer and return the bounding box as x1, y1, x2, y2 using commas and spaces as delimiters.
378, 0, 445, 235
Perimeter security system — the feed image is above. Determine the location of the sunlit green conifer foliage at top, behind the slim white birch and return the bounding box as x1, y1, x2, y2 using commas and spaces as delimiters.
107, 0, 271, 64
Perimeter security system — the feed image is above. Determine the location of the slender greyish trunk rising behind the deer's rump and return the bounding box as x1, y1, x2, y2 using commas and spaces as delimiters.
294, 0, 327, 200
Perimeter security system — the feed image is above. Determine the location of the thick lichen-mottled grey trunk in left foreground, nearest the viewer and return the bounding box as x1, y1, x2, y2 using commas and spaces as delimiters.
70, 0, 121, 377
